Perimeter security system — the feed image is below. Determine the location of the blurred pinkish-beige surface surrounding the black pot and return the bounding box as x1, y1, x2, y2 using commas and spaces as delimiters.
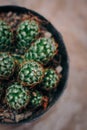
0, 0, 87, 130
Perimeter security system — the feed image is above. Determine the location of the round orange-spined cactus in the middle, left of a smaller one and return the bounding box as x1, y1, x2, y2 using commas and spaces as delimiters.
18, 61, 44, 87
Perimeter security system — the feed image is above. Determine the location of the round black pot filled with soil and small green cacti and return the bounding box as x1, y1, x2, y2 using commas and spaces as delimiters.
0, 6, 68, 123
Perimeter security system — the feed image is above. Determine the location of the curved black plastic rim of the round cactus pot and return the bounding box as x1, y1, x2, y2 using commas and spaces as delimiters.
0, 6, 69, 124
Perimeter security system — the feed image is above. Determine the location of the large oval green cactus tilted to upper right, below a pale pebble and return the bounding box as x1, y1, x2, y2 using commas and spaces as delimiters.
25, 38, 57, 64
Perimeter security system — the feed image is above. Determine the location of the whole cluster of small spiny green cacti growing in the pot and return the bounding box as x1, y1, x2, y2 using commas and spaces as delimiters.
0, 20, 60, 114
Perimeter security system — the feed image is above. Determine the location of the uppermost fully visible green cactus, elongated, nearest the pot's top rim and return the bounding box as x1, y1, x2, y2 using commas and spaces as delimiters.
17, 20, 39, 50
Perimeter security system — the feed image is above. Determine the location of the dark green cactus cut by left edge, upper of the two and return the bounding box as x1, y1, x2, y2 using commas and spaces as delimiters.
0, 20, 12, 51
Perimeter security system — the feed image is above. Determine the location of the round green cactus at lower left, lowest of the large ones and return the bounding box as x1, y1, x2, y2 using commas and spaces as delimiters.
5, 83, 30, 110
